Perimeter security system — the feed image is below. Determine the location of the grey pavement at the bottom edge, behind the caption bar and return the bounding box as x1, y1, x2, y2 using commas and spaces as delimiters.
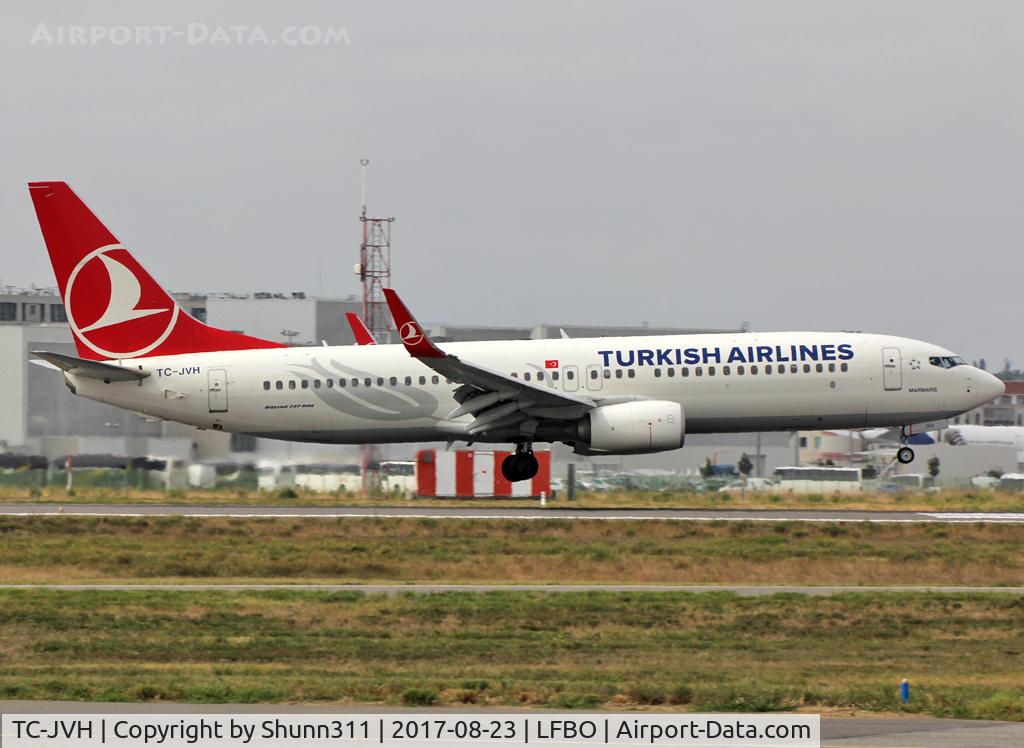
0, 701, 1024, 748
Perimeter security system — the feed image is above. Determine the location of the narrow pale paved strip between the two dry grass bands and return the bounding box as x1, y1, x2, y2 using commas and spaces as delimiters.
0, 583, 1024, 597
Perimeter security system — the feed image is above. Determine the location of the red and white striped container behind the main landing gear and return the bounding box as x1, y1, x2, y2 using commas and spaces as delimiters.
416, 450, 551, 499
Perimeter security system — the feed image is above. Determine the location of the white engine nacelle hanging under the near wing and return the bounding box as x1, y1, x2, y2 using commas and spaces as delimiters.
575, 400, 686, 455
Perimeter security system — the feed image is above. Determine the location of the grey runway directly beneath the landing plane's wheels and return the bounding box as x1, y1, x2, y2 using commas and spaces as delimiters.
0, 503, 1024, 524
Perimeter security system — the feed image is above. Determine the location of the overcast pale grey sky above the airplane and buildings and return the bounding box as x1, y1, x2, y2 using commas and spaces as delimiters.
0, 0, 1024, 368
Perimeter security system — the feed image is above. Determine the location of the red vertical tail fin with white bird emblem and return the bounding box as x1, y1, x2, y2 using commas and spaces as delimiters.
29, 181, 283, 361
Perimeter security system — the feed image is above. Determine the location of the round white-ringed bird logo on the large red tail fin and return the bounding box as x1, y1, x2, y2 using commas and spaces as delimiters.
65, 244, 179, 359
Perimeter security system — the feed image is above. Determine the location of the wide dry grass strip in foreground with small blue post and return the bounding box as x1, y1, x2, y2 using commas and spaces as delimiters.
0, 590, 1024, 719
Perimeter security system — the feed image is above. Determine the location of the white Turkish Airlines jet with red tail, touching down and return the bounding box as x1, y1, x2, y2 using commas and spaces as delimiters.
29, 181, 1004, 481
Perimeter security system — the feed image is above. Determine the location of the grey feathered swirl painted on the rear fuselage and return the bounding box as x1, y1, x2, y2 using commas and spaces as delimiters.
292, 359, 442, 421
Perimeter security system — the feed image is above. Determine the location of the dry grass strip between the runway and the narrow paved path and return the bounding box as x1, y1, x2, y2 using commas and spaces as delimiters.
0, 516, 1024, 586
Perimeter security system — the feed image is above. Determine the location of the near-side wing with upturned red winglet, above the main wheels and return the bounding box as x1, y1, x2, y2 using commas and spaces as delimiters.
384, 288, 595, 435
